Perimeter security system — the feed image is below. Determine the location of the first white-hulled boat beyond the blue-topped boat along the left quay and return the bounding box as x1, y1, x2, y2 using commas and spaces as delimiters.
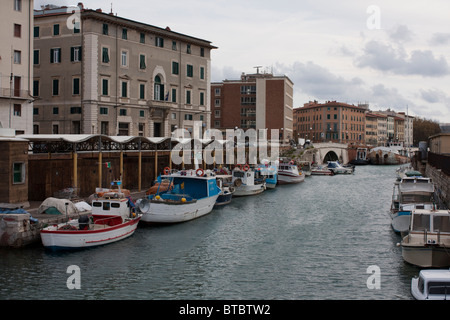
231, 165, 266, 197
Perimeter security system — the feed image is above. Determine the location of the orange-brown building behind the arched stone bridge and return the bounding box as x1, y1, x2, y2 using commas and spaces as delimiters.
294, 101, 367, 143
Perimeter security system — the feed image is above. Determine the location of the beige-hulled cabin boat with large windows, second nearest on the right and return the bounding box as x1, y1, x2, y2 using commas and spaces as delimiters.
400, 210, 450, 268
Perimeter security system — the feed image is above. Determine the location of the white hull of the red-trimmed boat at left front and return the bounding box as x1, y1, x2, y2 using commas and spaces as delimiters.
41, 216, 141, 250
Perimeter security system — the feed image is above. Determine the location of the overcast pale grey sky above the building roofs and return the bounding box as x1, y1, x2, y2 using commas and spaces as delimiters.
35, 0, 450, 123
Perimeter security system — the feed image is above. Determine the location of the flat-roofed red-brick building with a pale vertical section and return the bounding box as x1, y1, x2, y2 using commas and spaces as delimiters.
211, 72, 294, 142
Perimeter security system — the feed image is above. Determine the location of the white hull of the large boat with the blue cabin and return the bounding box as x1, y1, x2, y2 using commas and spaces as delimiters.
142, 194, 219, 224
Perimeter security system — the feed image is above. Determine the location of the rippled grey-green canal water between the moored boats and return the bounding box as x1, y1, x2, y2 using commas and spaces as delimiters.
0, 166, 419, 300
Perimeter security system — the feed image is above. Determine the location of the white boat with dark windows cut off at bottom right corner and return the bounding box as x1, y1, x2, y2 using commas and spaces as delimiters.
411, 269, 450, 300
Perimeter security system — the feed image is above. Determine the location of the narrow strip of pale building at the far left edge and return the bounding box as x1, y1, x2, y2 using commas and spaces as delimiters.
0, 0, 34, 134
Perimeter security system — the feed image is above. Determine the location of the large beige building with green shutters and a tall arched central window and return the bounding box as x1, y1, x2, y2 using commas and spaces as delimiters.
33, 3, 216, 137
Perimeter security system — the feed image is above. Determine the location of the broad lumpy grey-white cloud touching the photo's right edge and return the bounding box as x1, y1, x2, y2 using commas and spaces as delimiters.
355, 40, 450, 77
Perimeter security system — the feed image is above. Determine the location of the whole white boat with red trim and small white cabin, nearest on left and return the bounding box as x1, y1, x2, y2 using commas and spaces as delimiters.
41, 180, 141, 250
